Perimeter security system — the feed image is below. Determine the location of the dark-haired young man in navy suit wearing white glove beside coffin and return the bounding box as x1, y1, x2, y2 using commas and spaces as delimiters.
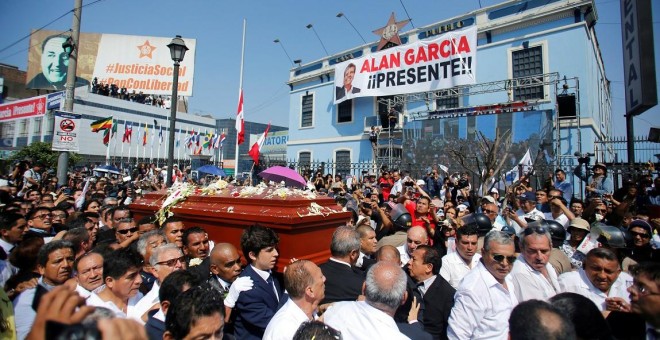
234, 225, 287, 339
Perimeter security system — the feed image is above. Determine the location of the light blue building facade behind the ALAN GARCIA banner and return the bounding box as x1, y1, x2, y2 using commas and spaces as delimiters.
287, 0, 612, 172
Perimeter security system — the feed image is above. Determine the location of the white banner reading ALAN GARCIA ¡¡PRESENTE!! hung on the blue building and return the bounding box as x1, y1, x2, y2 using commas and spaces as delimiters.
335, 27, 477, 104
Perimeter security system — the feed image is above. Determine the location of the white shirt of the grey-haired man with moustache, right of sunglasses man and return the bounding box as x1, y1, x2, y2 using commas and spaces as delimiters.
509, 254, 561, 302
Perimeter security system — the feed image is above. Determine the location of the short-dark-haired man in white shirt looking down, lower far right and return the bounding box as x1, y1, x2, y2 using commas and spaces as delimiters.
559, 248, 632, 312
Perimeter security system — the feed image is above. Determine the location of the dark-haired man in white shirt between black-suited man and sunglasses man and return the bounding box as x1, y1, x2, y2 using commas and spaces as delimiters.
440, 224, 481, 289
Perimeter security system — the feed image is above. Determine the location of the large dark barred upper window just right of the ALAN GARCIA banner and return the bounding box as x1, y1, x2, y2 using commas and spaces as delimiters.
511, 46, 545, 100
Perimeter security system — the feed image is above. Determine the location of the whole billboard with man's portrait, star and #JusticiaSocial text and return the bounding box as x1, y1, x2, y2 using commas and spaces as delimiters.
26, 31, 196, 96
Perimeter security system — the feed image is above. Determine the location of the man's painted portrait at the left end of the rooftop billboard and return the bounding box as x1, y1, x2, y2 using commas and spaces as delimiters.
26, 34, 89, 90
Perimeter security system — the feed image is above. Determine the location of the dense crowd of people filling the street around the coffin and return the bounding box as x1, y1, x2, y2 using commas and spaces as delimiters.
0, 157, 660, 340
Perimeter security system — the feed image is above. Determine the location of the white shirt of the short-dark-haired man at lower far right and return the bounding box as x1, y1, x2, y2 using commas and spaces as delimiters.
559, 268, 633, 312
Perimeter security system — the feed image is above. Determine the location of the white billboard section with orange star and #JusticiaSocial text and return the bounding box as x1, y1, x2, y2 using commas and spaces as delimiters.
92, 34, 197, 96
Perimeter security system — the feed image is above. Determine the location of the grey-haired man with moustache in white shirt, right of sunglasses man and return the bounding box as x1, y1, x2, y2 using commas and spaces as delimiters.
509, 222, 561, 302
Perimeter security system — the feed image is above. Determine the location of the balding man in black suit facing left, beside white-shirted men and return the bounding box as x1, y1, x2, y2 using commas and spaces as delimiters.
408, 245, 456, 339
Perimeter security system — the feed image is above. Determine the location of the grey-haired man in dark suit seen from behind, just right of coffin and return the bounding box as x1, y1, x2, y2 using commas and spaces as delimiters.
319, 227, 365, 304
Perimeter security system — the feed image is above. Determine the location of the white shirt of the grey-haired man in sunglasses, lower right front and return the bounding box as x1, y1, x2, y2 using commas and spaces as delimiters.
447, 262, 518, 340
